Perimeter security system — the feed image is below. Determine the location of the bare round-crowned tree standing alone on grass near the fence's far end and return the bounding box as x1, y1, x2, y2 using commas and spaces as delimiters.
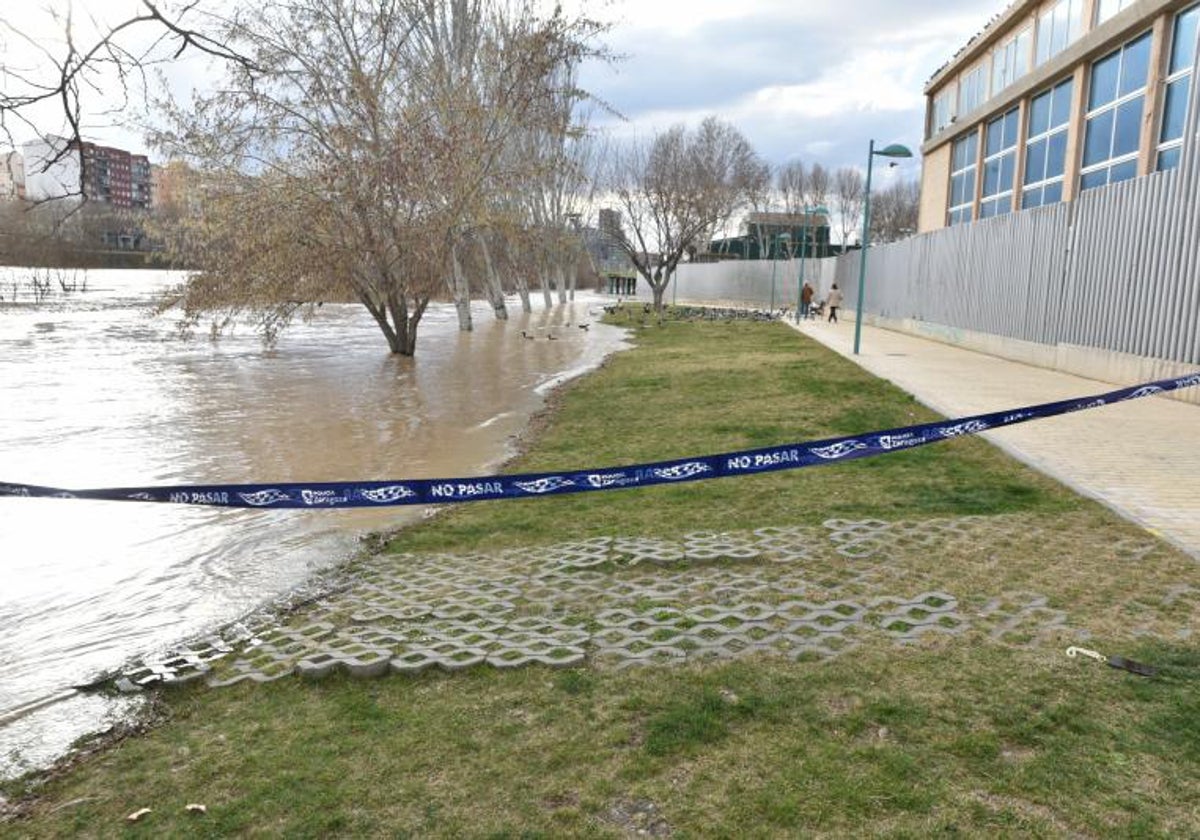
607, 116, 769, 312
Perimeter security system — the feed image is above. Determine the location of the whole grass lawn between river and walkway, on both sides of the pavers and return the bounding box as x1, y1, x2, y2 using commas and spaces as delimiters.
0, 322, 1200, 838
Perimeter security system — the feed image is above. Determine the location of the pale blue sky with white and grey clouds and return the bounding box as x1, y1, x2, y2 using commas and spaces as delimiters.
0, 0, 1009, 176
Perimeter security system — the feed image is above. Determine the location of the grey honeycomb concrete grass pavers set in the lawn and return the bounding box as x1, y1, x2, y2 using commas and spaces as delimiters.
122, 515, 1200, 688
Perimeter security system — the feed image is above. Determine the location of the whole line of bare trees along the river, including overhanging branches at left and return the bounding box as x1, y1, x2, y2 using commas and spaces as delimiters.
0, 0, 916, 355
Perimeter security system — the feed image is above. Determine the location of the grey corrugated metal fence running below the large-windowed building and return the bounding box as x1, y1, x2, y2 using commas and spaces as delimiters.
834, 160, 1200, 364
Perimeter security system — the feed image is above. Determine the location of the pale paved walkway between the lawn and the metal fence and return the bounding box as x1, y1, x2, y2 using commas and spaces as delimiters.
788, 319, 1200, 559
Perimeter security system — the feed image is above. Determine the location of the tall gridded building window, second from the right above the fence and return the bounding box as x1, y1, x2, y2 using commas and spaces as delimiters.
1080, 32, 1151, 190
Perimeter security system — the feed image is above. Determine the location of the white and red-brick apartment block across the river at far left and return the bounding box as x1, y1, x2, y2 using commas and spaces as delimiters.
22, 137, 151, 210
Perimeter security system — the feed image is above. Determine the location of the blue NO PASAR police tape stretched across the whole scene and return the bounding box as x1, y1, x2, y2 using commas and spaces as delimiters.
0, 374, 1200, 509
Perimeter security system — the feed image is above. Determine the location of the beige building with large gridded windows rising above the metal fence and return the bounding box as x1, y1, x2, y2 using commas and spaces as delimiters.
919, 0, 1200, 232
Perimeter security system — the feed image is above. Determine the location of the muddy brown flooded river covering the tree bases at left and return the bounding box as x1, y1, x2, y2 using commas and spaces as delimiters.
0, 269, 622, 775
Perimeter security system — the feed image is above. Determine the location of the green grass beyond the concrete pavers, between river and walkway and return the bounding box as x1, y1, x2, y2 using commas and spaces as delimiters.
392, 322, 1084, 551
